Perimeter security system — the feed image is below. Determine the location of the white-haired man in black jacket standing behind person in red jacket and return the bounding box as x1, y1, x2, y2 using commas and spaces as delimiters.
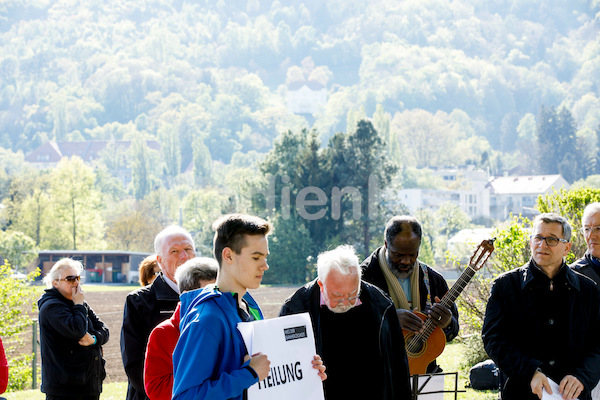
121, 226, 195, 400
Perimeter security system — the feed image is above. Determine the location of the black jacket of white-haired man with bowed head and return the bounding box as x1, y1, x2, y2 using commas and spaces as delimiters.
279, 279, 411, 400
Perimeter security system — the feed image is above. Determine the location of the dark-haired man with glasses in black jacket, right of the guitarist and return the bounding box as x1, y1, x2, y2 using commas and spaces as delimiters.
482, 213, 600, 400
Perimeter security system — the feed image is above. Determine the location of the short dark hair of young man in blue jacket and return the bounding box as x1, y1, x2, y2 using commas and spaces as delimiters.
213, 214, 273, 267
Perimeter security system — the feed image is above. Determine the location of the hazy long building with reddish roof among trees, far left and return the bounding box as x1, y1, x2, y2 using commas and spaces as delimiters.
25, 140, 160, 183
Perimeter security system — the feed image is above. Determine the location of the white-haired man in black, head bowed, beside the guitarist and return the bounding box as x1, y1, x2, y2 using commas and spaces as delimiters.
279, 246, 411, 400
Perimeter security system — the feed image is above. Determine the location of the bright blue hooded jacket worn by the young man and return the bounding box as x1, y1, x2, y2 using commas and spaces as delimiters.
173, 285, 263, 400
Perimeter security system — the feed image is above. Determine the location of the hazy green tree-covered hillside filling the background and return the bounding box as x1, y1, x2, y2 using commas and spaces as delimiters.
0, 0, 600, 280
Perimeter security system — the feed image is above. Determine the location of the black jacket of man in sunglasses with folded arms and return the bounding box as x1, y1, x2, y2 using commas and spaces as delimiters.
38, 288, 109, 396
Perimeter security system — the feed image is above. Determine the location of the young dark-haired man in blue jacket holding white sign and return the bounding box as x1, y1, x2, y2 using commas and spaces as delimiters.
173, 214, 325, 400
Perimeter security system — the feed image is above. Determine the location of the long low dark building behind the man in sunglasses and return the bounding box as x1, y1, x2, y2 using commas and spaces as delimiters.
30, 250, 150, 283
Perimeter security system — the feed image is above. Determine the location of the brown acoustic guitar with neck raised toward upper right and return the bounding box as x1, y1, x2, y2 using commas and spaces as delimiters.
402, 238, 496, 375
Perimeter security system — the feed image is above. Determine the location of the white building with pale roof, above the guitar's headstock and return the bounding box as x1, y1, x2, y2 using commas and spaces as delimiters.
488, 175, 570, 221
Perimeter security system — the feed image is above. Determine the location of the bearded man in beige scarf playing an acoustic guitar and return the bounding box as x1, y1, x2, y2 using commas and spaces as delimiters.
361, 216, 459, 375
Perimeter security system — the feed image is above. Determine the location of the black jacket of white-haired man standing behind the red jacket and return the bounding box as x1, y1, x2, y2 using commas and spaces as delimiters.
121, 273, 179, 400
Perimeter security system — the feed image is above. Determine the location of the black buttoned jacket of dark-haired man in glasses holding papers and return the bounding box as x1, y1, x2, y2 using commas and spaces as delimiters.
482, 260, 600, 400
